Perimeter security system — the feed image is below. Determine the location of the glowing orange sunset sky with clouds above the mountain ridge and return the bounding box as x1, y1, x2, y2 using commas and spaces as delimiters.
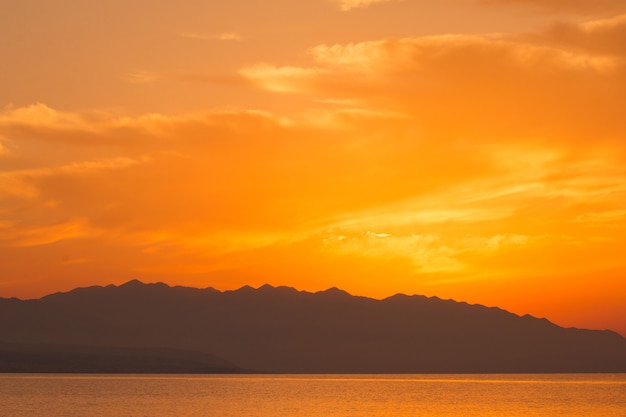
0, 0, 626, 335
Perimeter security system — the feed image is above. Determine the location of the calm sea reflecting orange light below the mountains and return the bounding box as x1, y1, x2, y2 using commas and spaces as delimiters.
0, 374, 626, 417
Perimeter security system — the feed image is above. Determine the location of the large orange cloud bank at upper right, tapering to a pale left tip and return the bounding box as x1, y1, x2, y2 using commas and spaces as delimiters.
241, 30, 626, 141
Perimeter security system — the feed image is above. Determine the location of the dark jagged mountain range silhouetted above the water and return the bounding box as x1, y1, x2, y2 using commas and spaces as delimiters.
0, 280, 626, 373
